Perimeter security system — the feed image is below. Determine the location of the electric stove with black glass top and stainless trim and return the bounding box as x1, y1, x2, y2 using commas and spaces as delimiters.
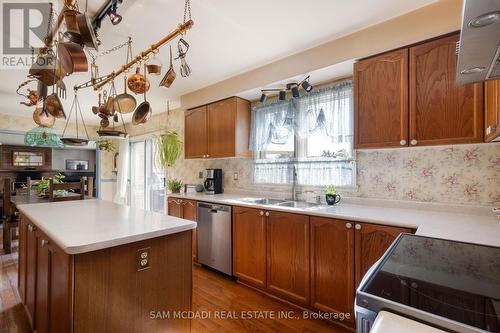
355, 234, 500, 333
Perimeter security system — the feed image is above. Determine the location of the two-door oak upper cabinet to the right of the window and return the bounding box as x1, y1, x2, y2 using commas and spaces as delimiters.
354, 34, 484, 149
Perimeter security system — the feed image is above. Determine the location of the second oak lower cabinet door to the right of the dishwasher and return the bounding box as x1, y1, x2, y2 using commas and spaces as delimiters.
267, 211, 310, 304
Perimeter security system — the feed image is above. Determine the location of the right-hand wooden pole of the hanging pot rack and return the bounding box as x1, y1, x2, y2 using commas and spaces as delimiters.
74, 20, 194, 91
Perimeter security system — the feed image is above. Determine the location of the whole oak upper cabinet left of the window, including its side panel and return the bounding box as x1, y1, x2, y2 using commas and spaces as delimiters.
184, 97, 251, 158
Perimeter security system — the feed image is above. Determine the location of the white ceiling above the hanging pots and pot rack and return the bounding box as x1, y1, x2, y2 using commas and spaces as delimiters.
0, 0, 435, 124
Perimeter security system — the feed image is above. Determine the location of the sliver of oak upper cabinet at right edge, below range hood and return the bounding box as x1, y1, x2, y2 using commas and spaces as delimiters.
484, 80, 500, 142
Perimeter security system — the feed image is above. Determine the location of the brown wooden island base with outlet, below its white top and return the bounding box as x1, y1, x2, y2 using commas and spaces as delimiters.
18, 214, 192, 333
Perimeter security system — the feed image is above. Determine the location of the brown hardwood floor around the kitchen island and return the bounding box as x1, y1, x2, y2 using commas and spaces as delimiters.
0, 229, 348, 333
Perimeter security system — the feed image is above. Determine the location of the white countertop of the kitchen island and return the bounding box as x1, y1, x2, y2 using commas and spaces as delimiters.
17, 199, 196, 254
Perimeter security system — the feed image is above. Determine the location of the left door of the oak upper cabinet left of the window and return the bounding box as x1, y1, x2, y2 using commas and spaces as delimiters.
184, 106, 208, 158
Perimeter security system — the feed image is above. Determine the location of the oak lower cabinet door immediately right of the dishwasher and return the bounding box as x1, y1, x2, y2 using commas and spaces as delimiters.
233, 207, 266, 288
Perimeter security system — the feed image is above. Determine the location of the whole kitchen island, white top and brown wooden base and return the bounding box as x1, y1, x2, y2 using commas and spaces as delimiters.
18, 200, 196, 333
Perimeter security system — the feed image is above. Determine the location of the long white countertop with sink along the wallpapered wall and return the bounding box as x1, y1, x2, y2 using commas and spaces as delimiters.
169, 193, 500, 246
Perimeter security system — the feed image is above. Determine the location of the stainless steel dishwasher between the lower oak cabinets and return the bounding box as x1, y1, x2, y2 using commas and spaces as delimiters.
198, 202, 233, 275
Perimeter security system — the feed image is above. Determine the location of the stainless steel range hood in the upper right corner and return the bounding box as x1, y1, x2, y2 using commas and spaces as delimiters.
456, 0, 500, 84
